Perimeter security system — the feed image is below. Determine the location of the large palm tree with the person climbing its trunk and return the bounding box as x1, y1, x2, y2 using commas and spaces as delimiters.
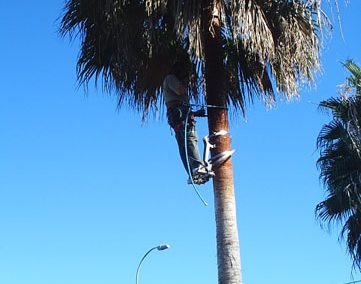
60, 0, 329, 284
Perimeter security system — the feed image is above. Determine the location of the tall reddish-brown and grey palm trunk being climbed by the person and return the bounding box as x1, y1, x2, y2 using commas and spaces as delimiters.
202, 0, 242, 284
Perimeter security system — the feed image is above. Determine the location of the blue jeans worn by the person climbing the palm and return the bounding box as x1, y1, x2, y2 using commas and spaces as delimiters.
167, 105, 203, 174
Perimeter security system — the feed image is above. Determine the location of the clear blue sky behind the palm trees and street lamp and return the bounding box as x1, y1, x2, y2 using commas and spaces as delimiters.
0, 0, 361, 284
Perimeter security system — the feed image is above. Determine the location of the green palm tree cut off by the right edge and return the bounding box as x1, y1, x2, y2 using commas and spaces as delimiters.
316, 60, 361, 270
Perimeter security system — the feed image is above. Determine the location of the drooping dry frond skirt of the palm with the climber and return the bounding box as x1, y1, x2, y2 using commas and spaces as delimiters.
60, 0, 327, 116
